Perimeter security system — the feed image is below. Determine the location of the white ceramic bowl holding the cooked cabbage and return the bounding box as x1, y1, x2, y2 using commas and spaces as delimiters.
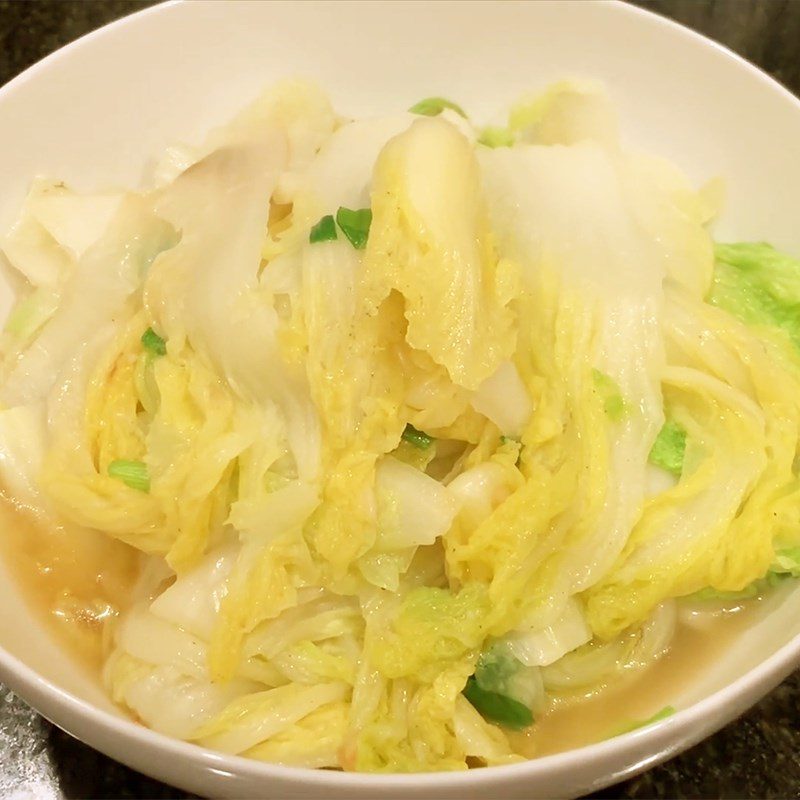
0, 2, 800, 800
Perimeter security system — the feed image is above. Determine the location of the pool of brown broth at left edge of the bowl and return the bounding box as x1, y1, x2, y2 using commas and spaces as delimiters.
0, 495, 140, 675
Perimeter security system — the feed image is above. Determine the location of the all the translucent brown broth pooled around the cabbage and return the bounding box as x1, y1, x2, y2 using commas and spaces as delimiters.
0, 499, 758, 758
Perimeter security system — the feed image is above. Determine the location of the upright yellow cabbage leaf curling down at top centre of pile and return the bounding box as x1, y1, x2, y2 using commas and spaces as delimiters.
366, 118, 517, 389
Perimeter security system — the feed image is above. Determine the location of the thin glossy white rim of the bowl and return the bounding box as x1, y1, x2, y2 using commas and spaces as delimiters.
0, 0, 800, 791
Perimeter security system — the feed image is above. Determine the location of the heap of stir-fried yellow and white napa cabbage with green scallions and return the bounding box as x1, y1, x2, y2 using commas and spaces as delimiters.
0, 78, 800, 771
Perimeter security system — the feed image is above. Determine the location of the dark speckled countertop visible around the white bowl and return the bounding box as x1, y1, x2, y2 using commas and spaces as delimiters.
0, 0, 800, 800
